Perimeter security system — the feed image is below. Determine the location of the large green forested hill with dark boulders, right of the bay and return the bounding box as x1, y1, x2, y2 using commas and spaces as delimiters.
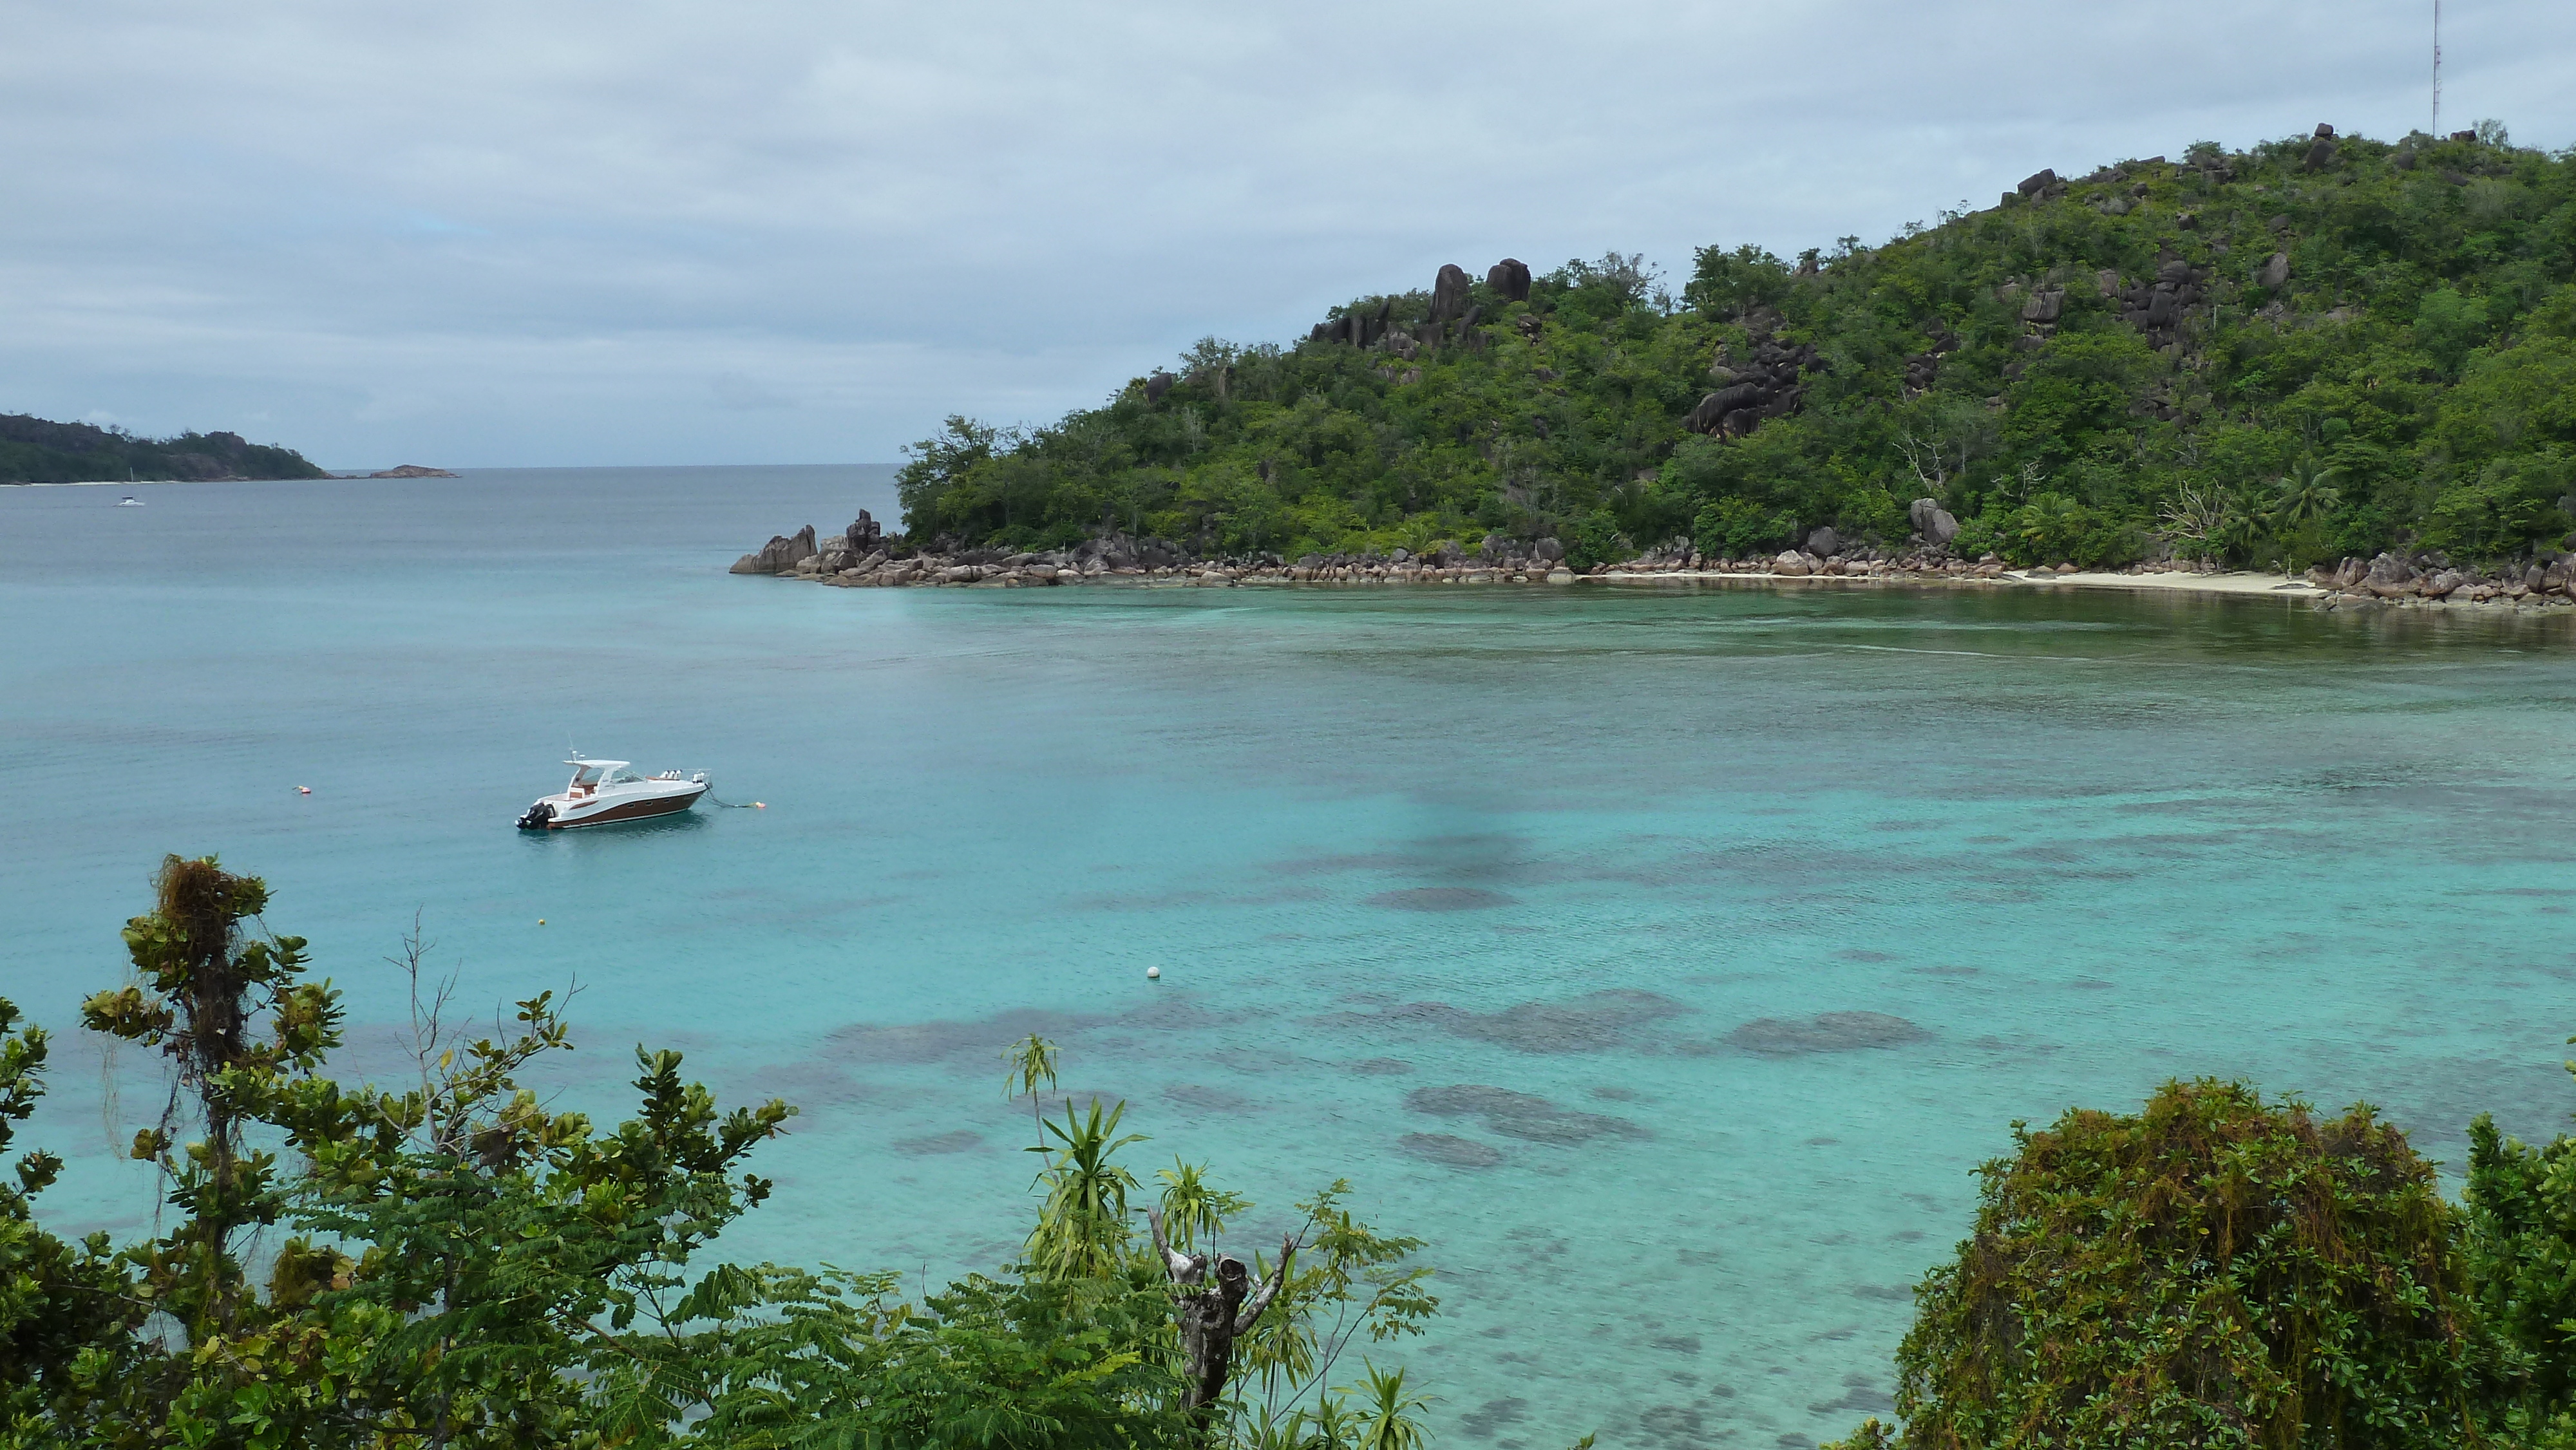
902, 124, 2576, 567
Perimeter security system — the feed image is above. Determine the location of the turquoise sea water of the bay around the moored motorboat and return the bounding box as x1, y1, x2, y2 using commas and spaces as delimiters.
0, 469, 2576, 1447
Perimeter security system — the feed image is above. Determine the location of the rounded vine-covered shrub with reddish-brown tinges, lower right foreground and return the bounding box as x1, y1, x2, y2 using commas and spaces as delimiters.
1896, 1079, 2476, 1450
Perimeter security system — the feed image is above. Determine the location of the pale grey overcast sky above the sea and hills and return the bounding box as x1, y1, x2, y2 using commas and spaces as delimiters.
0, 0, 2576, 466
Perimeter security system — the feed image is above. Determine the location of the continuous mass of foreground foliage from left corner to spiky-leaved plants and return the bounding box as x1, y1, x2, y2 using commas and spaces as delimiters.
0, 858, 1435, 1450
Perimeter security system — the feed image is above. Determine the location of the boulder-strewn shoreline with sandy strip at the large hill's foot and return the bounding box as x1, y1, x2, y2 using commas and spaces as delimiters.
732, 510, 2576, 608
